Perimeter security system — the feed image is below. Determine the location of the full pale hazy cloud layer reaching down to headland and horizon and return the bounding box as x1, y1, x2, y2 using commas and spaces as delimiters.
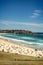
0, 21, 43, 32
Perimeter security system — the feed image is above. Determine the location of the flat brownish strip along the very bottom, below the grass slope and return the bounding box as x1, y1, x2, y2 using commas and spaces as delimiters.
0, 61, 43, 65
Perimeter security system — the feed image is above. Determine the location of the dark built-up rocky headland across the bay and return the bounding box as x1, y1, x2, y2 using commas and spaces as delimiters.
0, 30, 33, 34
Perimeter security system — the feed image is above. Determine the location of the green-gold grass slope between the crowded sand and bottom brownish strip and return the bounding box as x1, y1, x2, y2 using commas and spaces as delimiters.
0, 52, 43, 61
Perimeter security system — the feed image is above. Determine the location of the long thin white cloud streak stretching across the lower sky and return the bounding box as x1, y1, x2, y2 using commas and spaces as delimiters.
0, 21, 43, 28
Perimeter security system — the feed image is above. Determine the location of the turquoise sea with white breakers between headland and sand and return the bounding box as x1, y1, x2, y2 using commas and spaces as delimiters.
0, 34, 43, 49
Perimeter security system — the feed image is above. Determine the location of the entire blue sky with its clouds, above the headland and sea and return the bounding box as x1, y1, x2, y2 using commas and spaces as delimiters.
0, 0, 43, 32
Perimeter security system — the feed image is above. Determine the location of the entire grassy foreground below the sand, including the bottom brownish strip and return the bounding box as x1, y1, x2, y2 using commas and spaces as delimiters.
0, 52, 43, 65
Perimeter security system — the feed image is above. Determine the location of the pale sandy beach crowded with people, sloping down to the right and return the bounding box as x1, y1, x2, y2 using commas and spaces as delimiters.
0, 38, 43, 57
